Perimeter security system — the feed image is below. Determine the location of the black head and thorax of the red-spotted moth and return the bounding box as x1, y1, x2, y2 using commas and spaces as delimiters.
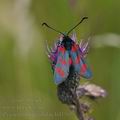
62, 36, 73, 50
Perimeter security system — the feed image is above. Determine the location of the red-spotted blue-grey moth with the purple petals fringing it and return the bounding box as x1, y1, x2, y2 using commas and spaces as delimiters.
42, 17, 92, 85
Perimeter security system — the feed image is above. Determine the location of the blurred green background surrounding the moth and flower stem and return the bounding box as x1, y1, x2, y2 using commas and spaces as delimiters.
0, 0, 120, 120
